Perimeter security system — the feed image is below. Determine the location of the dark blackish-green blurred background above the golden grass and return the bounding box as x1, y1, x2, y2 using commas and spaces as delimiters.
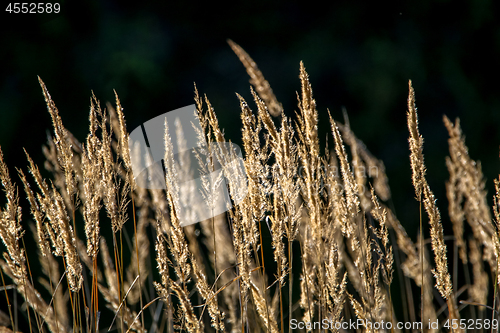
0, 0, 500, 326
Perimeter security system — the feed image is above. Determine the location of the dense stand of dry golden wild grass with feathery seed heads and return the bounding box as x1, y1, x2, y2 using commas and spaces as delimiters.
0, 41, 500, 333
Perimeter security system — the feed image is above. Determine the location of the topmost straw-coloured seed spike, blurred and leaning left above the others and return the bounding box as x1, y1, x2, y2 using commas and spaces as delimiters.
227, 39, 283, 117
